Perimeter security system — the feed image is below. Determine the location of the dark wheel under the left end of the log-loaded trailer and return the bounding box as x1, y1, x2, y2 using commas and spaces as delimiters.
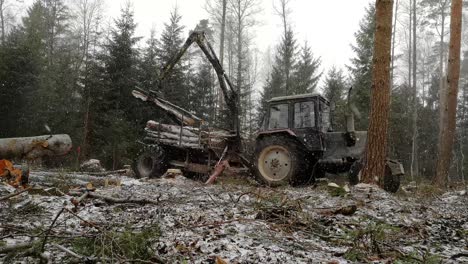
132, 146, 168, 178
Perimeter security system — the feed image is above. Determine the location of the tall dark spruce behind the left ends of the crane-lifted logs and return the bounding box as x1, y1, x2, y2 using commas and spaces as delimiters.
95, 5, 140, 168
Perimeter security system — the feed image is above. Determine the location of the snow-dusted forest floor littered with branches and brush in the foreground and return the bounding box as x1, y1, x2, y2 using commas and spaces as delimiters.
0, 171, 468, 264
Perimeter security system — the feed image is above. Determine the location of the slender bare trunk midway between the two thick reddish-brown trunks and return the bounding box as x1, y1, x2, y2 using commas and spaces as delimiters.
411, 0, 419, 180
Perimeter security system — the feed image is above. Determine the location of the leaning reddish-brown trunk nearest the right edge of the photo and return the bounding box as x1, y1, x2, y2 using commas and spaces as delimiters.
433, 0, 462, 187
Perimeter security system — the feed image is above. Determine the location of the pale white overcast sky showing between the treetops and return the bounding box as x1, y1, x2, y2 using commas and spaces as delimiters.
107, 0, 374, 78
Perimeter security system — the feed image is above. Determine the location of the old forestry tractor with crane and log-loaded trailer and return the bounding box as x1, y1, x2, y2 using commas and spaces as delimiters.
133, 31, 404, 192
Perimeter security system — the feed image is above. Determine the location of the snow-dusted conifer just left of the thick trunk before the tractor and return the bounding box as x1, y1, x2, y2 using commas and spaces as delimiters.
348, 4, 375, 130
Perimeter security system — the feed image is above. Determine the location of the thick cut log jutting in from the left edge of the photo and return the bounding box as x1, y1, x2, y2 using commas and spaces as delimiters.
0, 134, 72, 160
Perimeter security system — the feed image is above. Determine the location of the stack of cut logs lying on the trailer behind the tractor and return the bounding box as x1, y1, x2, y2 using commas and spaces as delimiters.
145, 120, 235, 148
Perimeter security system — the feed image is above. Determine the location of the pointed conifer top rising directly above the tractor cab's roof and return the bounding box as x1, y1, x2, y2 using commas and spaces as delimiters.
292, 42, 322, 94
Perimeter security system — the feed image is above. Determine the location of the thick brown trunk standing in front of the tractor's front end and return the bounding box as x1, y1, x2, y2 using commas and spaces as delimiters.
362, 0, 393, 184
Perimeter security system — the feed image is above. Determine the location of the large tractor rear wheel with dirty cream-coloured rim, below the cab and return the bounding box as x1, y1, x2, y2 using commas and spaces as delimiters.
255, 136, 310, 186
